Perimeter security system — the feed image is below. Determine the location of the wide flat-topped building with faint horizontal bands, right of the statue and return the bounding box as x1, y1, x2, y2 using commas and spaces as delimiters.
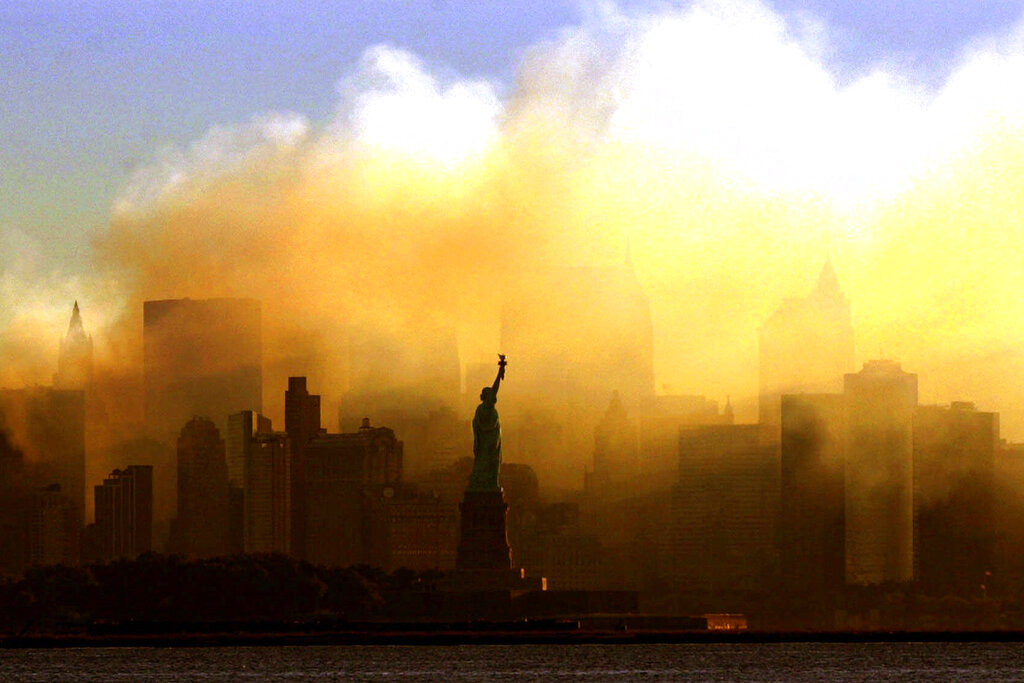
671, 425, 778, 592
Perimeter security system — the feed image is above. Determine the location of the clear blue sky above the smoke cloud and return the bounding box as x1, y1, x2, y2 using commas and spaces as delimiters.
0, 0, 1024, 268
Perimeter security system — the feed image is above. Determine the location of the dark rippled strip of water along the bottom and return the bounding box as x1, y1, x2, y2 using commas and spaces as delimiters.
0, 643, 1024, 683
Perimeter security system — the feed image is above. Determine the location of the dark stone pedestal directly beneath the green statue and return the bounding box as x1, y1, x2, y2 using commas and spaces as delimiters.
456, 489, 512, 575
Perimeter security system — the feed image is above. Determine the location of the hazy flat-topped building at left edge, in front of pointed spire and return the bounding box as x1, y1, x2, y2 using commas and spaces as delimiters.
0, 387, 85, 521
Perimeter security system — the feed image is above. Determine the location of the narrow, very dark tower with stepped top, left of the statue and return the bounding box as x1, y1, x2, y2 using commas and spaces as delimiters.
285, 377, 321, 559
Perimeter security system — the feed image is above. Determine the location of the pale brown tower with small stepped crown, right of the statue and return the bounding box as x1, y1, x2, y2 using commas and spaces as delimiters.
845, 360, 918, 585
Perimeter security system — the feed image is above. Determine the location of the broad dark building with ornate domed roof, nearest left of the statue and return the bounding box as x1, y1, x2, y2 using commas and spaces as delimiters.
305, 420, 402, 566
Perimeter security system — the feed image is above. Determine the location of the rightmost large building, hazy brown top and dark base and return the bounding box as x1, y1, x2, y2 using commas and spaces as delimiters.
913, 402, 999, 598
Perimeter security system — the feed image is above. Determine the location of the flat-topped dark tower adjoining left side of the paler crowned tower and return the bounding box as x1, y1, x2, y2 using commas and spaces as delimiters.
778, 394, 846, 602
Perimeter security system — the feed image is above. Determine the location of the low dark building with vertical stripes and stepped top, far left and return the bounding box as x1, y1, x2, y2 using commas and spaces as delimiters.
91, 465, 153, 560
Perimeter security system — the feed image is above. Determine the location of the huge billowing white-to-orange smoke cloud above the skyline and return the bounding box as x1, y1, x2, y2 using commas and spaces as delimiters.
6, 0, 1024, 439
